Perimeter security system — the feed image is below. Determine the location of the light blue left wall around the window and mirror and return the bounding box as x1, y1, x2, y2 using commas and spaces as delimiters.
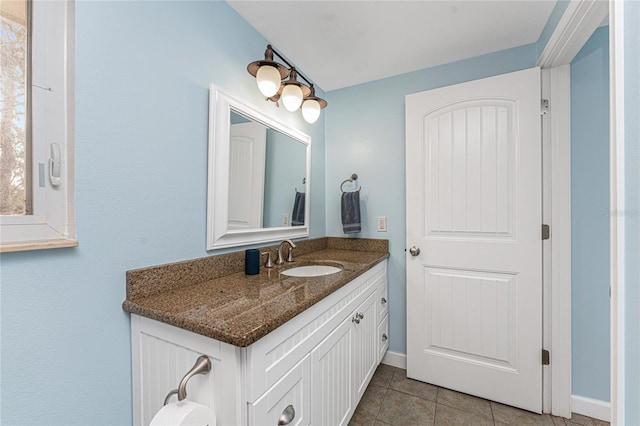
0, 1, 326, 425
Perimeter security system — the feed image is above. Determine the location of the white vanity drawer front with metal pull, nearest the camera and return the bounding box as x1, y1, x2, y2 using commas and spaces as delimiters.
249, 355, 311, 426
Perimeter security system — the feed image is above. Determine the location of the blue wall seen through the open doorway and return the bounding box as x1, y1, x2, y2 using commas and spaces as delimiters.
571, 27, 610, 401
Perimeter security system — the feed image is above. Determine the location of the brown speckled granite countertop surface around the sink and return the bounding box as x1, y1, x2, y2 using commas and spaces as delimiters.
122, 239, 389, 347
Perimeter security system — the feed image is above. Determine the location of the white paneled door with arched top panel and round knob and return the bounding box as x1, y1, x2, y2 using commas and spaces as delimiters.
406, 68, 542, 413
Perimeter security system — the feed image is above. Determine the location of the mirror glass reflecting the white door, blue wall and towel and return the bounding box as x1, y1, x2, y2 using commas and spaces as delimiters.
228, 110, 306, 230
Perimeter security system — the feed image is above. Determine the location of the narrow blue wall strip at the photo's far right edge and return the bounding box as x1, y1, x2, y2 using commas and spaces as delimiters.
622, 1, 640, 425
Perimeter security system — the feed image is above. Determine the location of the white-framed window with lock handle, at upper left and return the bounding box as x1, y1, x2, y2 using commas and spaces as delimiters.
0, 0, 77, 251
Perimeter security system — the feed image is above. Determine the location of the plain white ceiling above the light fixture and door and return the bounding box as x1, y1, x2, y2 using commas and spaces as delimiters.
227, 0, 555, 91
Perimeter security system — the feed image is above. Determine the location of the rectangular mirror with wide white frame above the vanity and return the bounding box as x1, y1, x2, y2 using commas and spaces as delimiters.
207, 84, 311, 250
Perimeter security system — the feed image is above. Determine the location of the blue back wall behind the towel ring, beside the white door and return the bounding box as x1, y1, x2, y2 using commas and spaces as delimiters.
326, 44, 537, 354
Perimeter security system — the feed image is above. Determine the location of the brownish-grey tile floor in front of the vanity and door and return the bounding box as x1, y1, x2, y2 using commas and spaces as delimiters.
349, 364, 609, 426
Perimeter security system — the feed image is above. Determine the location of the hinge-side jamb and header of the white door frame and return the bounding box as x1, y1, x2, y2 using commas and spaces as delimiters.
536, 0, 615, 418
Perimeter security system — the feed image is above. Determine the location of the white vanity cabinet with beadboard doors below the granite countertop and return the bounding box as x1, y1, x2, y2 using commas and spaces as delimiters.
131, 261, 388, 426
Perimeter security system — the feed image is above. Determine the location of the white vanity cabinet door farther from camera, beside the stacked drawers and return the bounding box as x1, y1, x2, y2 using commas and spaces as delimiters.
350, 293, 378, 402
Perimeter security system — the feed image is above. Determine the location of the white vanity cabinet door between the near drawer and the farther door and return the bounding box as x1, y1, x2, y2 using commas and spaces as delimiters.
311, 317, 355, 425
